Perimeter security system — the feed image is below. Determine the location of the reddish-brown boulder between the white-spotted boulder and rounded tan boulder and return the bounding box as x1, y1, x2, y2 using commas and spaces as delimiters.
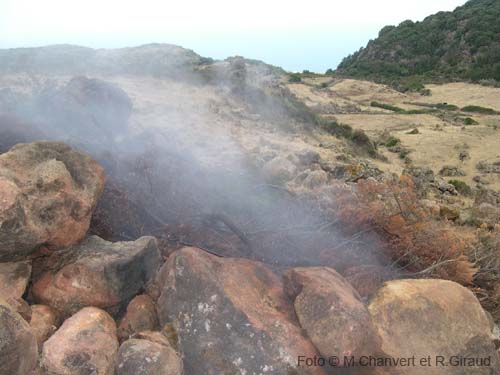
283, 267, 381, 359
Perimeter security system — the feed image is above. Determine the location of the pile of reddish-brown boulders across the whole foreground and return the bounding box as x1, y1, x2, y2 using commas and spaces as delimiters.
0, 142, 500, 375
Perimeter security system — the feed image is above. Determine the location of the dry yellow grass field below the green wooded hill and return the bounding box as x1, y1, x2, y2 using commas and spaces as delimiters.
291, 79, 500, 190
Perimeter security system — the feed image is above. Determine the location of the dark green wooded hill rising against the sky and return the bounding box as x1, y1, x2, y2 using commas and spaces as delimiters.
337, 0, 500, 81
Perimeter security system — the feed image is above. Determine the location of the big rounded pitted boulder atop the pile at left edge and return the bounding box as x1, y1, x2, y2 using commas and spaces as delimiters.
0, 142, 104, 262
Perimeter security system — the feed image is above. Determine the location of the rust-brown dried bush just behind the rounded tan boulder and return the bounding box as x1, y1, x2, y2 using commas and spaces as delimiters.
336, 176, 477, 285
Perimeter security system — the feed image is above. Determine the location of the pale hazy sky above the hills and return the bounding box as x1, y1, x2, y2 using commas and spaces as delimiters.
0, 0, 466, 72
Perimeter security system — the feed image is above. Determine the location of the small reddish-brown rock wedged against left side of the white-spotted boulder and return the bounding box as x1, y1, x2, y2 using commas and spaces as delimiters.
118, 294, 158, 341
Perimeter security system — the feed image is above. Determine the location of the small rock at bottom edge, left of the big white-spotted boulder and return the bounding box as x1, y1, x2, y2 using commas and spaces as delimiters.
115, 339, 183, 375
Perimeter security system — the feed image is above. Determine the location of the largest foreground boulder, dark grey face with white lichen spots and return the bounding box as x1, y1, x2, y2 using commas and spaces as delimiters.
158, 247, 321, 375
